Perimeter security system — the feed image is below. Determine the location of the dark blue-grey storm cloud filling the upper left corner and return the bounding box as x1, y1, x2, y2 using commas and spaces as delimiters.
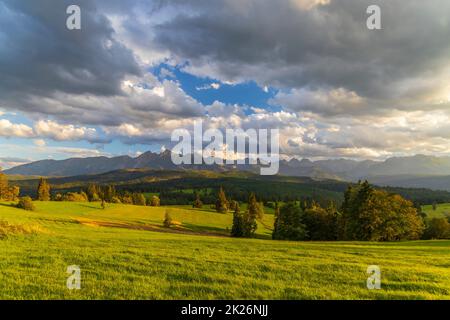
0, 0, 140, 102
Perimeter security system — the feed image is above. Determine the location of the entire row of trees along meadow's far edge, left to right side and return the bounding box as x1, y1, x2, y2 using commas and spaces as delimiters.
0, 172, 450, 241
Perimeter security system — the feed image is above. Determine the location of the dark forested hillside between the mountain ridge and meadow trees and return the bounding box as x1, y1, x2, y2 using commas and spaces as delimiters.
10, 169, 450, 206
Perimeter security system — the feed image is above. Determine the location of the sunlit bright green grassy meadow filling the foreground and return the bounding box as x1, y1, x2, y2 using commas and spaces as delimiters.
0, 202, 450, 299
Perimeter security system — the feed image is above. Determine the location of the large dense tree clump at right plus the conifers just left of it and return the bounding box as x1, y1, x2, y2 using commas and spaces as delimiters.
231, 181, 450, 241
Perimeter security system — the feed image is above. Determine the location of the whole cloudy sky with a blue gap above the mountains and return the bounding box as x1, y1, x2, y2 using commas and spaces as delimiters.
0, 0, 450, 168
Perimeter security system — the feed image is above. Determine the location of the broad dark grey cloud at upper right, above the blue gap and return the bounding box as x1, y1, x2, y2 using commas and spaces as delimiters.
152, 0, 450, 98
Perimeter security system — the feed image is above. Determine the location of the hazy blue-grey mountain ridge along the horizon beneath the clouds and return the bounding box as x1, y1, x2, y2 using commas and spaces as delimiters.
4, 154, 450, 190
